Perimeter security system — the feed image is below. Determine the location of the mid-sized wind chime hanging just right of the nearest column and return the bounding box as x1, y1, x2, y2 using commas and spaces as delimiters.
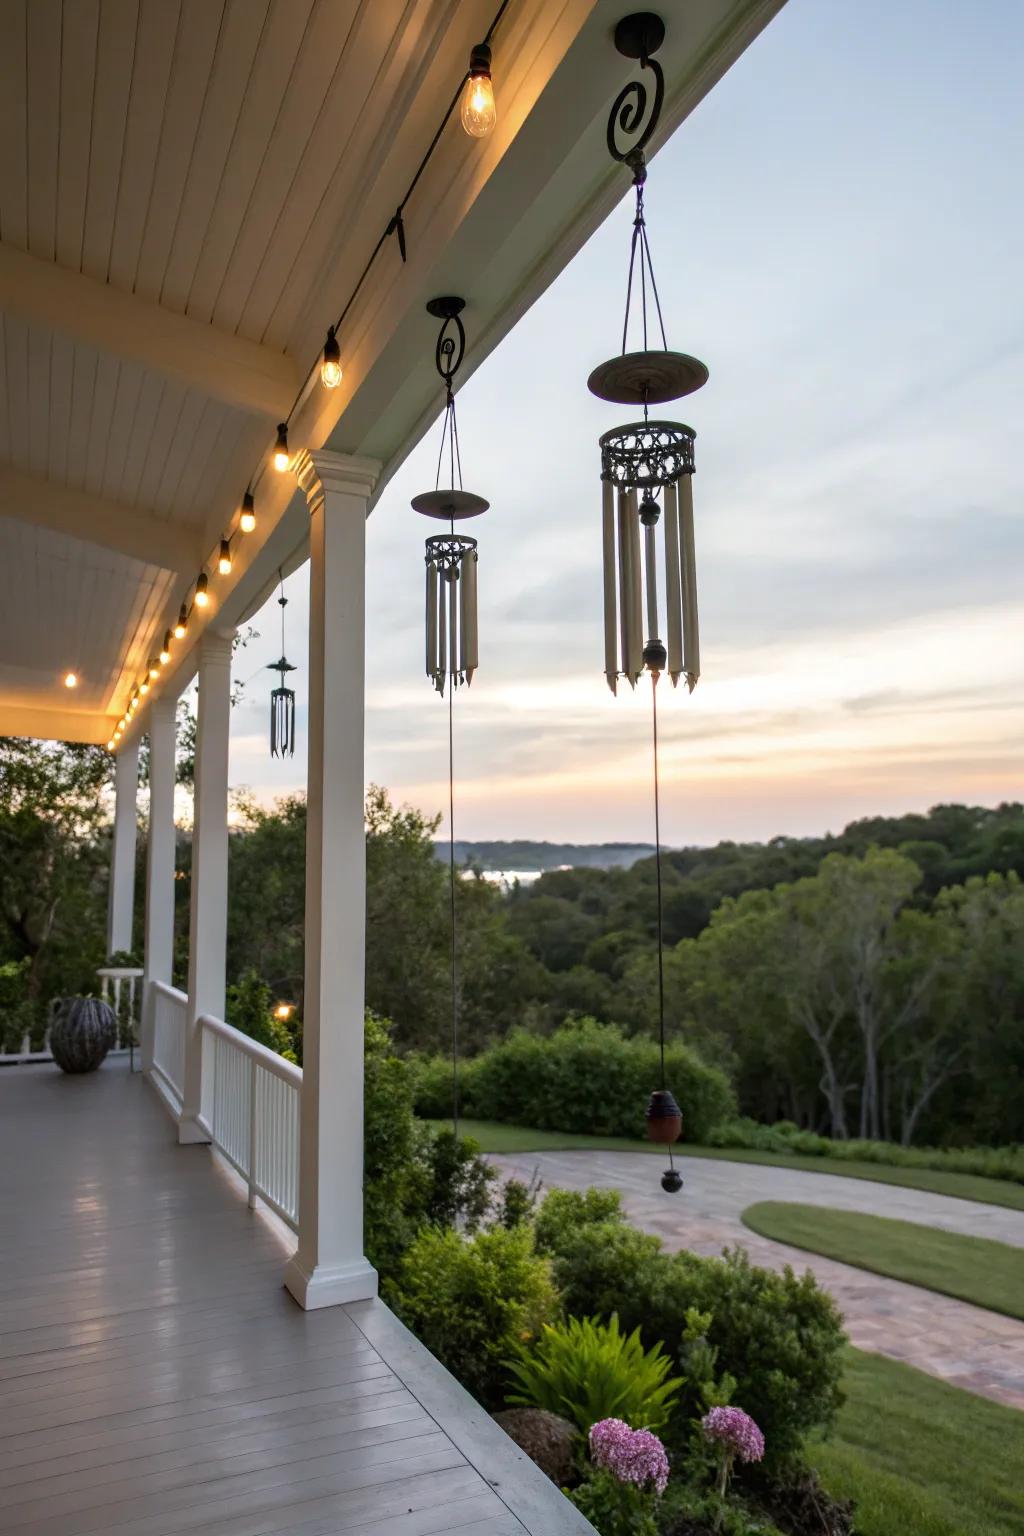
413, 298, 490, 1135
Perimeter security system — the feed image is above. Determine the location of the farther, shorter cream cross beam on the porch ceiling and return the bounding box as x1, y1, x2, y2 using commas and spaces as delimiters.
0, 464, 203, 574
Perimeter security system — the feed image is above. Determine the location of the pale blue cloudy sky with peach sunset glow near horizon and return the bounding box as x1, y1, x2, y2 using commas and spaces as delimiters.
224, 0, 1024, 845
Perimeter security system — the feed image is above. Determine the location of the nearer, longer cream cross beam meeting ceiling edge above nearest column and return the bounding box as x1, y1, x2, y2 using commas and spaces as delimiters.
0, 244, 299, 421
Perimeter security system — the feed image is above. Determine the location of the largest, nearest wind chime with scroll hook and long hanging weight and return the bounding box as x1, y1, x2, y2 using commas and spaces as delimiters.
588, 11, 708, 1193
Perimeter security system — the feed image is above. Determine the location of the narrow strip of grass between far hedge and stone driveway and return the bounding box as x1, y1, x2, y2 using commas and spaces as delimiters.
427, 1120, 1024, 1210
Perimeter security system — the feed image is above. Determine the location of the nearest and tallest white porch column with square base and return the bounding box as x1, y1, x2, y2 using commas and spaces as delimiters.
284, 452, 381, 1307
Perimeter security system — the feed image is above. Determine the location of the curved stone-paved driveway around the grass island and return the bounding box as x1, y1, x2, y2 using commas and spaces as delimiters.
490, 1152, 1024, 1409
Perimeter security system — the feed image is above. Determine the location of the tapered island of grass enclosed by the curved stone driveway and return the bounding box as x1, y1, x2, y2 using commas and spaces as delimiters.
743, 1200, 1024, 1318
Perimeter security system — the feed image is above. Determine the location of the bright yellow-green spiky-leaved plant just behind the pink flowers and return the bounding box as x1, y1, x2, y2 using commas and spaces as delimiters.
507, 1313, 682, 1435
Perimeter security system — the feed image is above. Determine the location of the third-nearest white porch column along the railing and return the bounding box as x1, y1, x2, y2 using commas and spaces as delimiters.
140, 699, 178, 1072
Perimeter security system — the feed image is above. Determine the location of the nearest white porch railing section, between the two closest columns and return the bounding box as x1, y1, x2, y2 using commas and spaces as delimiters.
200, 1014, 302, 1232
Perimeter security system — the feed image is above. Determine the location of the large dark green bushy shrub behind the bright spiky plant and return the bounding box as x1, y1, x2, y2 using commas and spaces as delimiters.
542, 1197, 843, 1465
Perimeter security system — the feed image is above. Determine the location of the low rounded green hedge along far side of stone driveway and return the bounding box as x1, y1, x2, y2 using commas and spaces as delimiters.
413, 1018, 735, 1141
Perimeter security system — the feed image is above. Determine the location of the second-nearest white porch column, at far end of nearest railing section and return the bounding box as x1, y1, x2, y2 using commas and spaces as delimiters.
178, 631, 232, 1141
